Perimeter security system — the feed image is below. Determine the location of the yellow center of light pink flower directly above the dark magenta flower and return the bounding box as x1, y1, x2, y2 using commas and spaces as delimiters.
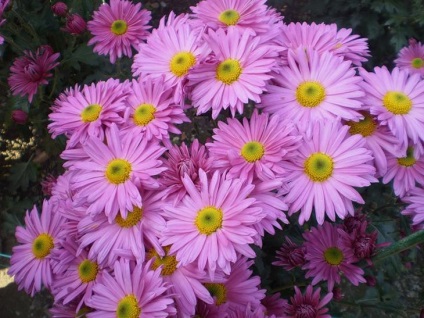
304, 152, 333, 182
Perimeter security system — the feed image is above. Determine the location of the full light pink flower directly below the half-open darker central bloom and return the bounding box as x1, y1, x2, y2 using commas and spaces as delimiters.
161, 170, 263, 279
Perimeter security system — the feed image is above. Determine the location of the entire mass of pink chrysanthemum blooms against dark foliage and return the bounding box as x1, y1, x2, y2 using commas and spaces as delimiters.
5, 0, 424, 318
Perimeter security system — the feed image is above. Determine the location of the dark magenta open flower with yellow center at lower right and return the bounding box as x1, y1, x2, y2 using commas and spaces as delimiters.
302, 222, 365, 291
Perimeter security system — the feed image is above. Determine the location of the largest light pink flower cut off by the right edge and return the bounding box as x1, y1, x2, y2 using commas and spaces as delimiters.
359, 66, 424, 153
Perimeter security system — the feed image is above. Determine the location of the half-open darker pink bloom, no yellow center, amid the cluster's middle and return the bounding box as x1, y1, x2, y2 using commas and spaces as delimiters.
159, 139, 212, 205
